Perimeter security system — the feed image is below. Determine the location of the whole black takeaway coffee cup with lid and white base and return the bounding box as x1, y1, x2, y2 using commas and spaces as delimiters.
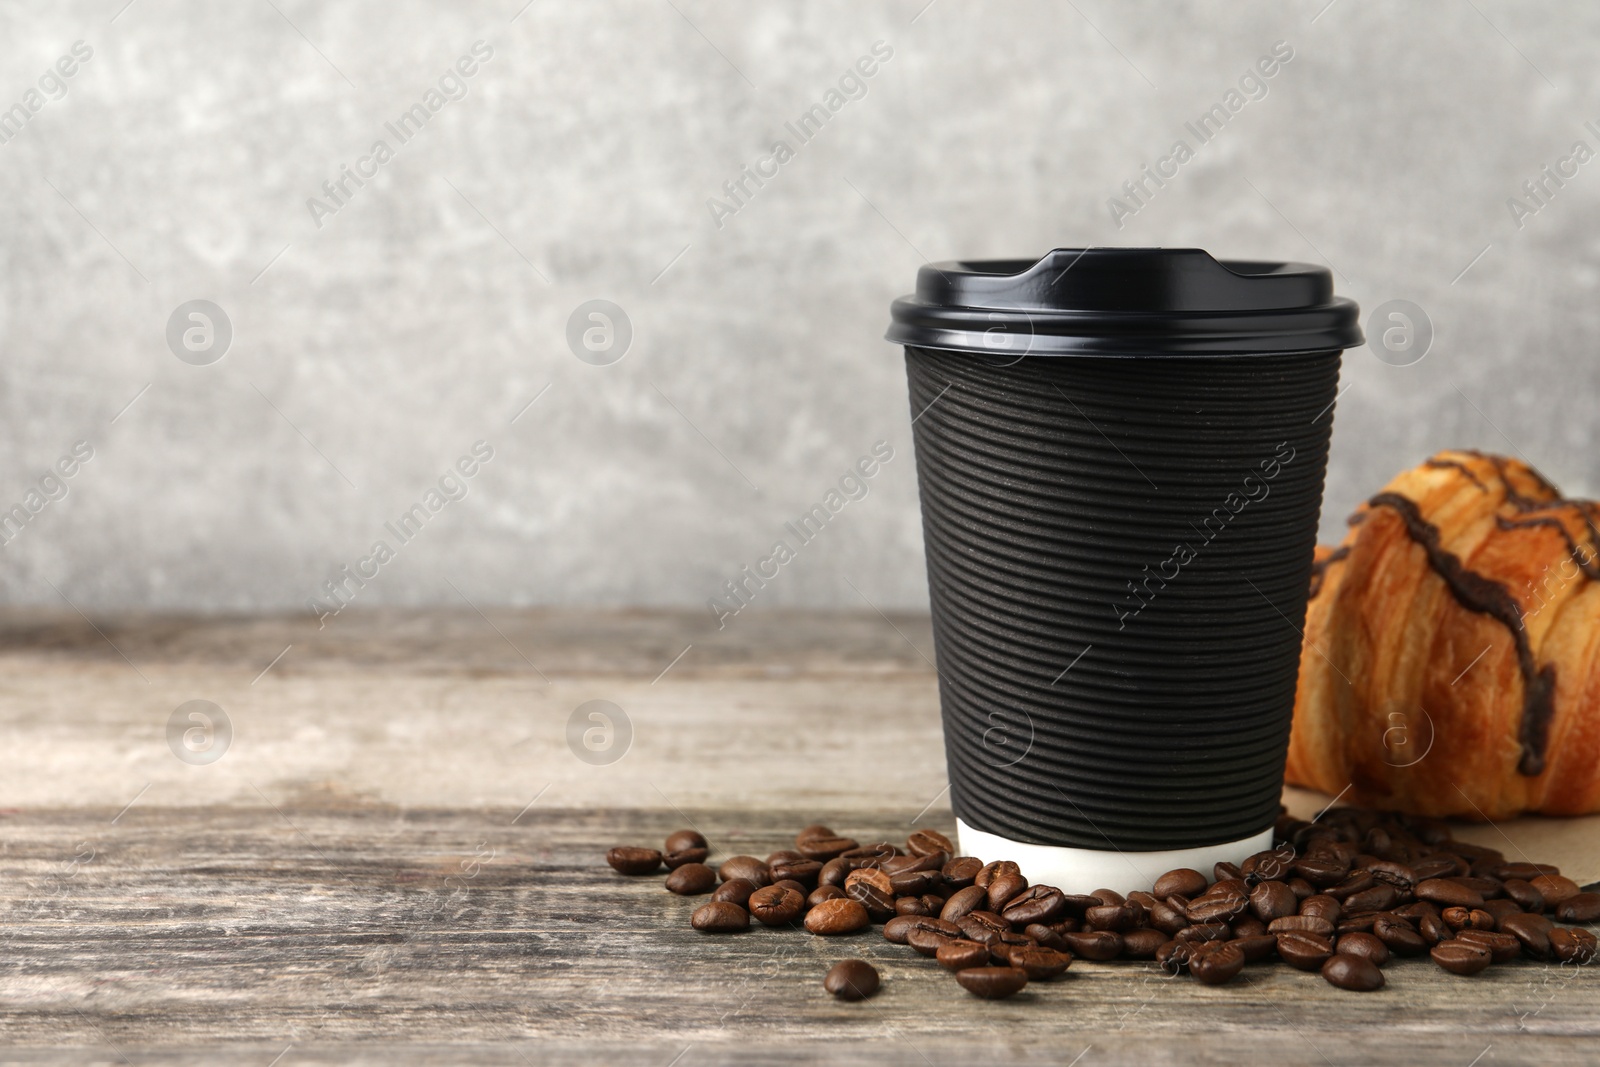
888, 248, 1362, 893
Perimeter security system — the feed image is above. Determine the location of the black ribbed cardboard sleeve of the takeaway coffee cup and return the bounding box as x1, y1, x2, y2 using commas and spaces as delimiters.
906, 347, 1339, 851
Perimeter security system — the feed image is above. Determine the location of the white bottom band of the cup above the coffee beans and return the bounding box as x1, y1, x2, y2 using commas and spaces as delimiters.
955, 819, 1272, 894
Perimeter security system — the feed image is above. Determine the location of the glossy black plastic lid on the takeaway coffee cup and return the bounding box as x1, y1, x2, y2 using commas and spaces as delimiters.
886, 248, 1362, 357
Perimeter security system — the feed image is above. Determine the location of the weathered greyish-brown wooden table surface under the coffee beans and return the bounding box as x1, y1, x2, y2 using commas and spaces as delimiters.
0, 611, 1600, 1067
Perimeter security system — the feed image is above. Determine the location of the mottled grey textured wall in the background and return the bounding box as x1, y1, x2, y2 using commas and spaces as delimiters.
0, 0, 1600, 609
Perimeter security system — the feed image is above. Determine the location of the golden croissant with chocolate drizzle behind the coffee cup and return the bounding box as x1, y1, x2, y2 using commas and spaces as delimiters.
1285, 451, 1600, 819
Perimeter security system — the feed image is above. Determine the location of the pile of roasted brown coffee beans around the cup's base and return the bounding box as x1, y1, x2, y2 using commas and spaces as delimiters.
606, 808, 1600, 1000
